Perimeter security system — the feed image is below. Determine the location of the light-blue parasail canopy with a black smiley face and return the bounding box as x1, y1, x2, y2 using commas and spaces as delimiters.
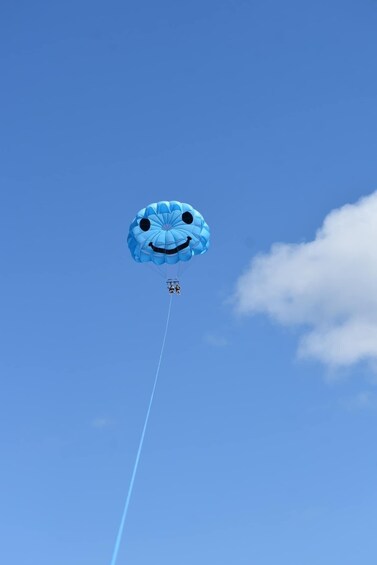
127, 200, 210, 265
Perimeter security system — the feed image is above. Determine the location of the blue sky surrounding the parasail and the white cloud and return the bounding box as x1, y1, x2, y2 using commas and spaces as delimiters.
0, 0, 377, 565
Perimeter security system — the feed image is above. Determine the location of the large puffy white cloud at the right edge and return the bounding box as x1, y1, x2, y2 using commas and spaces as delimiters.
235, 192, 377, 367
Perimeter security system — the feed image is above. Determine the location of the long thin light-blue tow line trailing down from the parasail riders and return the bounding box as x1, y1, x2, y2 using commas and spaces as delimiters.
111, 295, 173, 565
